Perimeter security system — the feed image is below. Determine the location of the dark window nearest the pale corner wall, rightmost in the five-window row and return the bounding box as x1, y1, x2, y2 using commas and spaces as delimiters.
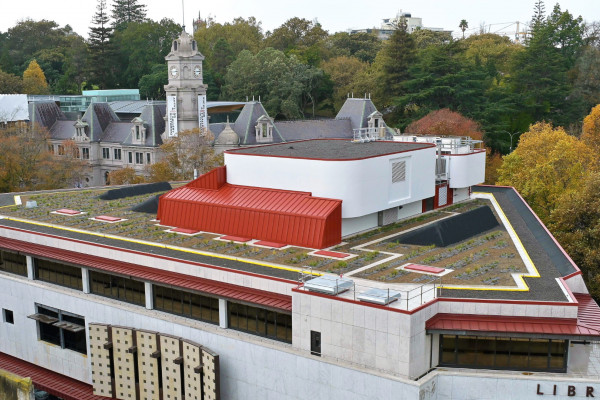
227, 302, 292, 343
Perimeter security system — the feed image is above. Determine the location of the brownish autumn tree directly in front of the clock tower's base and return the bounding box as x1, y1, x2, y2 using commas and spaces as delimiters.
148, 129, 223, 182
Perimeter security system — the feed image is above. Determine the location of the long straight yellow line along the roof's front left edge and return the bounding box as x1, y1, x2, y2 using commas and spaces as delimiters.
5, 217, 322, 276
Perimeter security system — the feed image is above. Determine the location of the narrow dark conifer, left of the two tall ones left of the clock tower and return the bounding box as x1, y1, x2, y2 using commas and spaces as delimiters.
89, 0, 113, 89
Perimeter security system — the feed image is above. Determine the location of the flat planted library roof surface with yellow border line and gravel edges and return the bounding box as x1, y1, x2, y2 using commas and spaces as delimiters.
0, 184, 575, 301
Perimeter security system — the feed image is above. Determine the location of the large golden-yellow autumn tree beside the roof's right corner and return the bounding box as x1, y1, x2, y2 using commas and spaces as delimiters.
497, 122, 598, 221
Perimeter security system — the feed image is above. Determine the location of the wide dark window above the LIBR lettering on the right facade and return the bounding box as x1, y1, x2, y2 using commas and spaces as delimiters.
440, 335, 568, 372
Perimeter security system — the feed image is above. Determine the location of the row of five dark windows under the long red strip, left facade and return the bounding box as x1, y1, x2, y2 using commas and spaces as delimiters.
0, 251, 292, 343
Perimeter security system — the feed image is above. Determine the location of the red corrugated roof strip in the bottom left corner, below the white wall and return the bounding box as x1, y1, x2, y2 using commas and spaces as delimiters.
0, 353, 109, 400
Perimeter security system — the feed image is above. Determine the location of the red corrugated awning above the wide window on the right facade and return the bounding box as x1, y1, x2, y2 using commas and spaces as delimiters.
426, 294, 600, 340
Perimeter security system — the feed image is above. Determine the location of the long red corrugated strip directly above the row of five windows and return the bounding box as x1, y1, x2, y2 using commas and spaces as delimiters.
0, 238, 292, 311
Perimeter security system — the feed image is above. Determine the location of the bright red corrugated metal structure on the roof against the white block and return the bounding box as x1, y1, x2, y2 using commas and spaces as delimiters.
156, 169, 342, 249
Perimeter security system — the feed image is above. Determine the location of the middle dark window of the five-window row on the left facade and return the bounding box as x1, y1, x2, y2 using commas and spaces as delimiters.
89, 271, 146, 306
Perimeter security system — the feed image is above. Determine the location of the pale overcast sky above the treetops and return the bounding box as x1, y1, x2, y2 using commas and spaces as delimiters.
0, 0, 600, 37
